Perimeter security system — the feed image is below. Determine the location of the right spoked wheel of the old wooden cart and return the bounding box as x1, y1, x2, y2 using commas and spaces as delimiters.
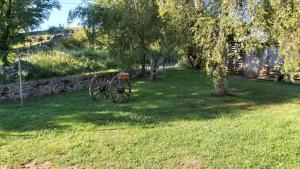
109, 76, 131, 104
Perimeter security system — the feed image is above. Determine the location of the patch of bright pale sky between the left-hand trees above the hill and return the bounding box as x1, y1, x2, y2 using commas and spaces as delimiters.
38, 0, 82, 30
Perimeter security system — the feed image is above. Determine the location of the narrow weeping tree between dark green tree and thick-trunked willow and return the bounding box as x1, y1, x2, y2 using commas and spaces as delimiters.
159, 0, 202, 68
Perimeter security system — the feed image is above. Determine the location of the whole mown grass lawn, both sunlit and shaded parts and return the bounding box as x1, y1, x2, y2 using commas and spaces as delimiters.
0, 70, 300, 169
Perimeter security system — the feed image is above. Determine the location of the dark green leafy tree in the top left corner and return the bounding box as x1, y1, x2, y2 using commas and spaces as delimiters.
0, 0, 60, 65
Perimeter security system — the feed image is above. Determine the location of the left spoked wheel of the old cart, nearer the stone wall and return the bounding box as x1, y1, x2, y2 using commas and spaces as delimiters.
89, 75, 109, 101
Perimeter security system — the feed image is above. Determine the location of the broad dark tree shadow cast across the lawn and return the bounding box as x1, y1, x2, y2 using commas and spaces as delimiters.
0, 70, 300, 132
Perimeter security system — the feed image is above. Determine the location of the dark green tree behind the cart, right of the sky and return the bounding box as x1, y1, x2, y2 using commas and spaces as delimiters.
70, 0, 162, 70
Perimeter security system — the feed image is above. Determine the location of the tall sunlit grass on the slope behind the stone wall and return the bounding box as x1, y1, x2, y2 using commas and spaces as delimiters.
0, 49, 111, 84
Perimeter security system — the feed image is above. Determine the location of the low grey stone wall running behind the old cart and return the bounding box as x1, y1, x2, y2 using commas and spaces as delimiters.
0, 70, 143, 101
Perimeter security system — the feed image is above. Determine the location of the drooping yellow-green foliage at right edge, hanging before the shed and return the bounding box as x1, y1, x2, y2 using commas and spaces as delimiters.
248, 0, 300, 78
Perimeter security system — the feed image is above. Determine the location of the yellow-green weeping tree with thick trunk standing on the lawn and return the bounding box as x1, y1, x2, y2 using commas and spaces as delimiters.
194, 0, 247, 96
